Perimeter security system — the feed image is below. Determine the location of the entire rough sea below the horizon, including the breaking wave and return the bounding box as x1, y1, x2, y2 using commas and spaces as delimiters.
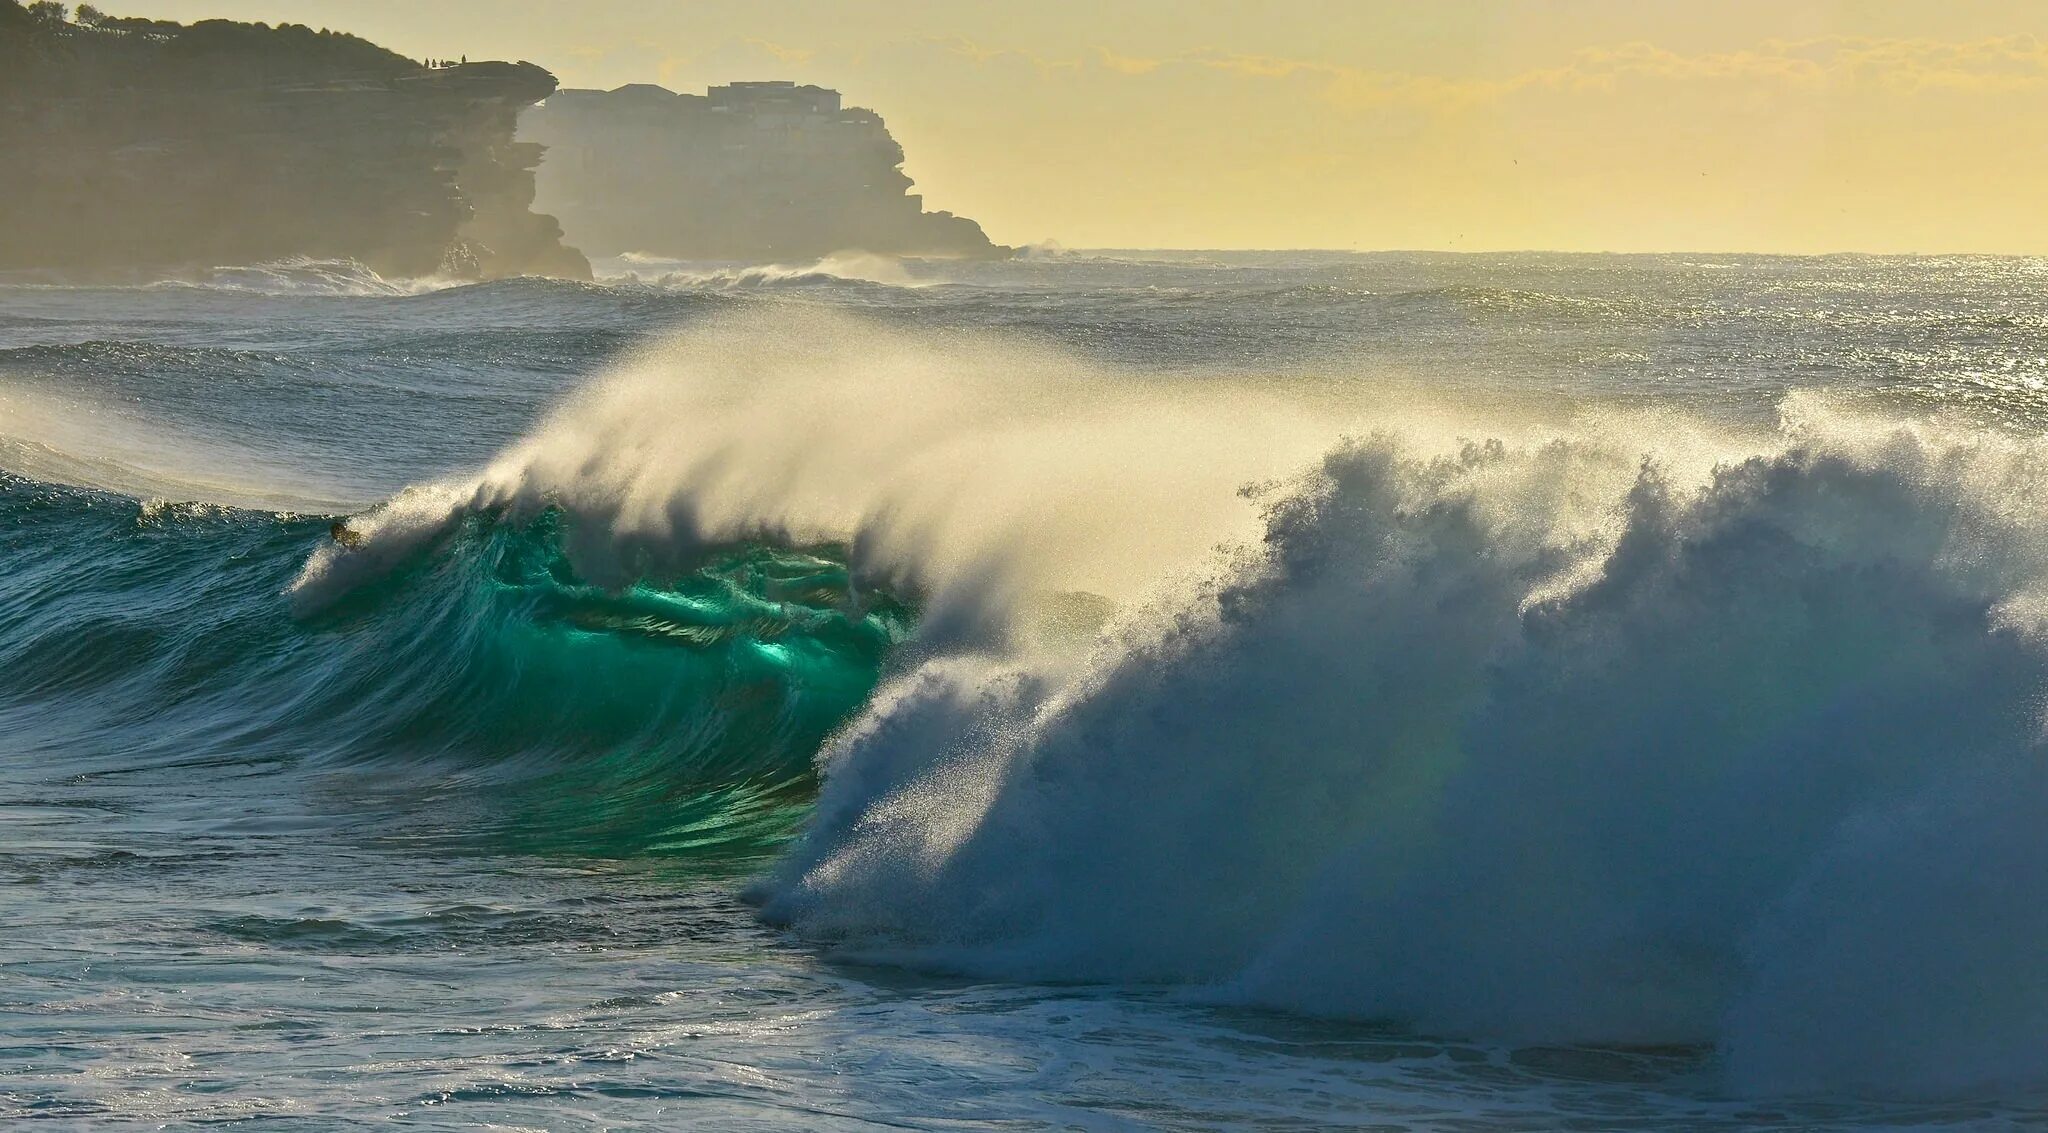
0, 250, 2048, 1133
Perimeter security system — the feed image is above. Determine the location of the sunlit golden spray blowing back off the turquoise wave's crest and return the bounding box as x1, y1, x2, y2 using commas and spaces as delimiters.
293, 307, 1359, 626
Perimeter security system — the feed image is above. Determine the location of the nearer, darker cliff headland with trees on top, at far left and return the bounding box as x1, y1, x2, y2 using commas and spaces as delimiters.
0, 0, 590, 279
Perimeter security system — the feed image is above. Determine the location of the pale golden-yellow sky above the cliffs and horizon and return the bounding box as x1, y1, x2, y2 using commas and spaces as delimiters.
119, 0, 2048, 254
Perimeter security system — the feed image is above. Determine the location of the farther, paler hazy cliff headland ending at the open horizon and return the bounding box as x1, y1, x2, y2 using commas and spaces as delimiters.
520, 82, 1012, 262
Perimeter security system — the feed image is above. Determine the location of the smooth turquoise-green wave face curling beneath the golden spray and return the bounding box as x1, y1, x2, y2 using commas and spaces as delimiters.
0, 481, 911, 856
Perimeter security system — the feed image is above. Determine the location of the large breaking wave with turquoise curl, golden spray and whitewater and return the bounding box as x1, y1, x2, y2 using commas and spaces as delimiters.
16, 309, 2048, 1094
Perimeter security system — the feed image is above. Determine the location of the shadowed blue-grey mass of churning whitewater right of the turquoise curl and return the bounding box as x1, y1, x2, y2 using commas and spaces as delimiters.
766, 405, 2048, 1092
